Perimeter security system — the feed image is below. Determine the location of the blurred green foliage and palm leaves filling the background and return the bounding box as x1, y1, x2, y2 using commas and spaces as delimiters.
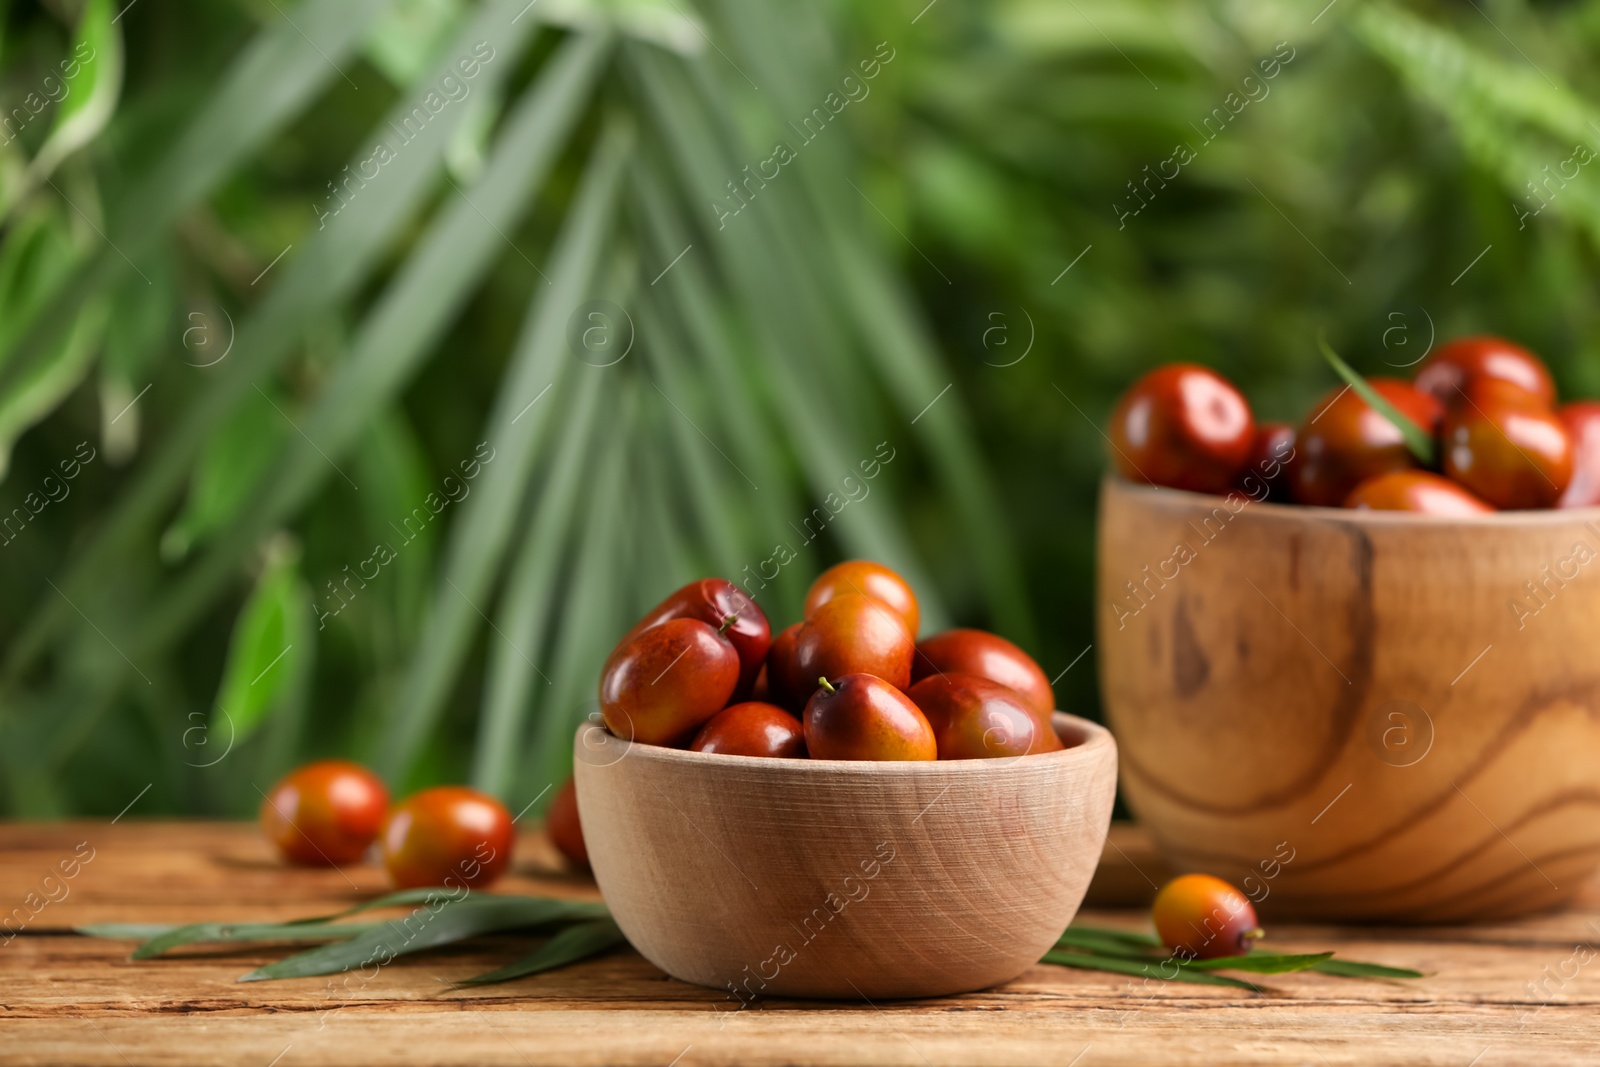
0, 0, 1600, 816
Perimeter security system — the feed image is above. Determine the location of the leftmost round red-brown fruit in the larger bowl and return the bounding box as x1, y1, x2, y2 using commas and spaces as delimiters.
1109, 363, 1256, 493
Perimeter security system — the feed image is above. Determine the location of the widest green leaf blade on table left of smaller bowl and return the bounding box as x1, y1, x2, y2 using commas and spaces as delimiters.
238, 897, 594, 982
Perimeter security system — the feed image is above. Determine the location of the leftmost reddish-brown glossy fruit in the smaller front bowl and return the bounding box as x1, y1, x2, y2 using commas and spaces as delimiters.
600, 619, 739, 745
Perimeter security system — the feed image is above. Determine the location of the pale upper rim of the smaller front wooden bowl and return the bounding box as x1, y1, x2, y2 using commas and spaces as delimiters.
574, 710, 1115, 777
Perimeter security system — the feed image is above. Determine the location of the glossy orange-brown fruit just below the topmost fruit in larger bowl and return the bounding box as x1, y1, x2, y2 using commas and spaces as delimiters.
1438, 391, 1574, 510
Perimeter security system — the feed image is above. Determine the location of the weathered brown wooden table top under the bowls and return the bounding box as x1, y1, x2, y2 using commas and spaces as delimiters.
0, 819, 1600, 1067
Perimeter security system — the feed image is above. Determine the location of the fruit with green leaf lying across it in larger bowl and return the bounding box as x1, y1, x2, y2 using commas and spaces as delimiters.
1290, 378, 1445, 507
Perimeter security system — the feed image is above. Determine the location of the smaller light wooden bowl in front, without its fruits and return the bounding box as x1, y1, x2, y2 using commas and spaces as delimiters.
576, 712, 1117, 1011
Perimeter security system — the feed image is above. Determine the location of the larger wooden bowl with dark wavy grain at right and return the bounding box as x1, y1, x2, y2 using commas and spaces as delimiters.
1096, 478, 1600, 921
